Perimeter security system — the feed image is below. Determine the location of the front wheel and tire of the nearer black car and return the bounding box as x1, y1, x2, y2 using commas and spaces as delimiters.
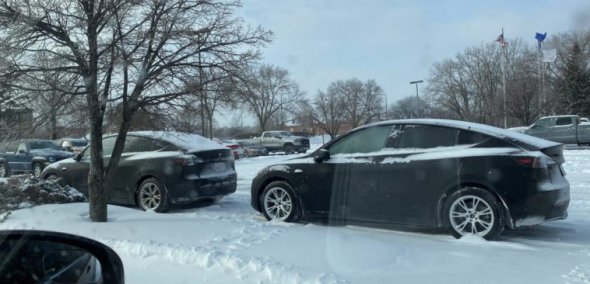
260, 181, 301, 222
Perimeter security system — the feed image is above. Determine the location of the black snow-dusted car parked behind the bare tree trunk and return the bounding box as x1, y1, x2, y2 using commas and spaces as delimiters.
41, 131, 237, 212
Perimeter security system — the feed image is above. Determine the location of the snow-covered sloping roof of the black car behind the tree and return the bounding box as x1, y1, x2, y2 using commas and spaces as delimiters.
127, 131, 227, 152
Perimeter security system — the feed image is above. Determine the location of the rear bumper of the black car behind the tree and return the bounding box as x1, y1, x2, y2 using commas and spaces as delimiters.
166, 174, 237, 204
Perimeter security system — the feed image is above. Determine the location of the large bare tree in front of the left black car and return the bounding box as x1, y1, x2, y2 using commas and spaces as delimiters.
0, 0, 270, 222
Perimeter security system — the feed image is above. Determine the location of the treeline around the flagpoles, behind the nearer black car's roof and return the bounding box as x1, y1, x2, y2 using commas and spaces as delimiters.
390, 31, 590, 126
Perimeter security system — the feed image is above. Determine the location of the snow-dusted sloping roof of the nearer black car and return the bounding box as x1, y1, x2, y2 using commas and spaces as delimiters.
359, 118, 561, 150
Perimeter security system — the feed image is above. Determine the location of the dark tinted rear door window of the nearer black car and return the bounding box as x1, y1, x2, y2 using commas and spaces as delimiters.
398, 125, 458, 148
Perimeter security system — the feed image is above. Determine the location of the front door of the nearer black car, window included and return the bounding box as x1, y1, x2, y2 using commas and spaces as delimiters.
306, 125, 391, 220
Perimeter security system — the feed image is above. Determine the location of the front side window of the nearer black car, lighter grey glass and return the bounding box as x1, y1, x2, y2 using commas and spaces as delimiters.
328, 125, 391, 155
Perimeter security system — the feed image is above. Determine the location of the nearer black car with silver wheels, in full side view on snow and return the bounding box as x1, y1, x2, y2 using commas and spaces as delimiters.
251, 119, 570, 239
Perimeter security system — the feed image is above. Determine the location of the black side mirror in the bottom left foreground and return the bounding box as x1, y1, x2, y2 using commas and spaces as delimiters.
0, 230, 125, 284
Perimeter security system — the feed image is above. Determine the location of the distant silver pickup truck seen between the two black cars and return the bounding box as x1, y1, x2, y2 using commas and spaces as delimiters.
248, 131, 309, 154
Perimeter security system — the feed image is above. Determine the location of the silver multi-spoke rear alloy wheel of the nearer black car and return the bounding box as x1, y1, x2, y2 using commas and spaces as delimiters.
449, 195, 495, 237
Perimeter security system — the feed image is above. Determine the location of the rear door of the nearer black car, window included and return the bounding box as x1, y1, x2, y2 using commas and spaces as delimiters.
379, 124, 460, 225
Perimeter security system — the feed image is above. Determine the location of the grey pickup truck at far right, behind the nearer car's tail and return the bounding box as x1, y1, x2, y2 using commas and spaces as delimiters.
514, 115, 590, 145
